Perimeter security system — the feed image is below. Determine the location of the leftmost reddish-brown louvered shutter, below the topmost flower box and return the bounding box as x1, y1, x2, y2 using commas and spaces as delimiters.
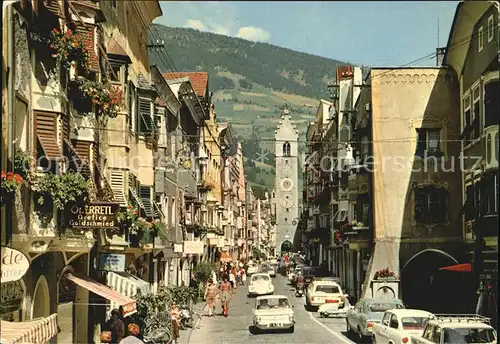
35, 111, 62, 160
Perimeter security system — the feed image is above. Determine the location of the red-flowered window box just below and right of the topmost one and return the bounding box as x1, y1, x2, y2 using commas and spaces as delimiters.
68, 78, 123, 118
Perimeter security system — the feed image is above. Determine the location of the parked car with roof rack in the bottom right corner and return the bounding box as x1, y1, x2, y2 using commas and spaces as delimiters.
410, 314, 497, 344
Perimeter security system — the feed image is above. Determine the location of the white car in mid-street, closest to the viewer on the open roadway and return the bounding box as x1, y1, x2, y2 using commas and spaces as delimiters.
250, 295, 295, 333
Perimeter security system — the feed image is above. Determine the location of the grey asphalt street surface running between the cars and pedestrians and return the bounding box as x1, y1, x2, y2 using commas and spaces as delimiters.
189, 275, 354, 344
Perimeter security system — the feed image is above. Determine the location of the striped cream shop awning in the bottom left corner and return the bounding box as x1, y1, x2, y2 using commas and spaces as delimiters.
0, 314, 57, 344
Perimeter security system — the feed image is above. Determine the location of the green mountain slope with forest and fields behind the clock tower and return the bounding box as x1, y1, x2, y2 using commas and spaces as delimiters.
151, 25, 345, 193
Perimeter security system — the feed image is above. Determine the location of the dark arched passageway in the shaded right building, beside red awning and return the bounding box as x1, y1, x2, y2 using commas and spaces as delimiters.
401, 249, 465, 313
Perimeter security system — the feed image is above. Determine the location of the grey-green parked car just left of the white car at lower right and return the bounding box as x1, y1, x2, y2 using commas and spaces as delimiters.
346, 299, 405, 341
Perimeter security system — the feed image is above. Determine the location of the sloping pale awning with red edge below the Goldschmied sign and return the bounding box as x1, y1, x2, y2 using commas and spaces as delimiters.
66, 273, 137, 317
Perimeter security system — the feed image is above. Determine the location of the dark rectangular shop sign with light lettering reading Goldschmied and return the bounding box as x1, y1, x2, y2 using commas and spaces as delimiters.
64, 203, 120, 229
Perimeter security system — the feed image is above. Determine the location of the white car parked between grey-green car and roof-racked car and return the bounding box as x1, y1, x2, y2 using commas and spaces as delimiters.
373, 309, 434, 344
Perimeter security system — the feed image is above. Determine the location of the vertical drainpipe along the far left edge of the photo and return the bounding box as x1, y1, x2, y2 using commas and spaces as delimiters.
3, 1, 18, 245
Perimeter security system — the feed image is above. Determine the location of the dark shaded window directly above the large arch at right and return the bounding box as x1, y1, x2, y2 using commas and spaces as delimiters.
415, 186, 447, 224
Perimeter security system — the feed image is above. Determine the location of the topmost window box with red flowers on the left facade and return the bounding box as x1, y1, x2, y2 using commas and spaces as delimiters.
47, 28, 90, 71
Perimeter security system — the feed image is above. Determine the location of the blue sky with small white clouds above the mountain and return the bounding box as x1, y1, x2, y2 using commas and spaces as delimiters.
155, 1, 458, 66
